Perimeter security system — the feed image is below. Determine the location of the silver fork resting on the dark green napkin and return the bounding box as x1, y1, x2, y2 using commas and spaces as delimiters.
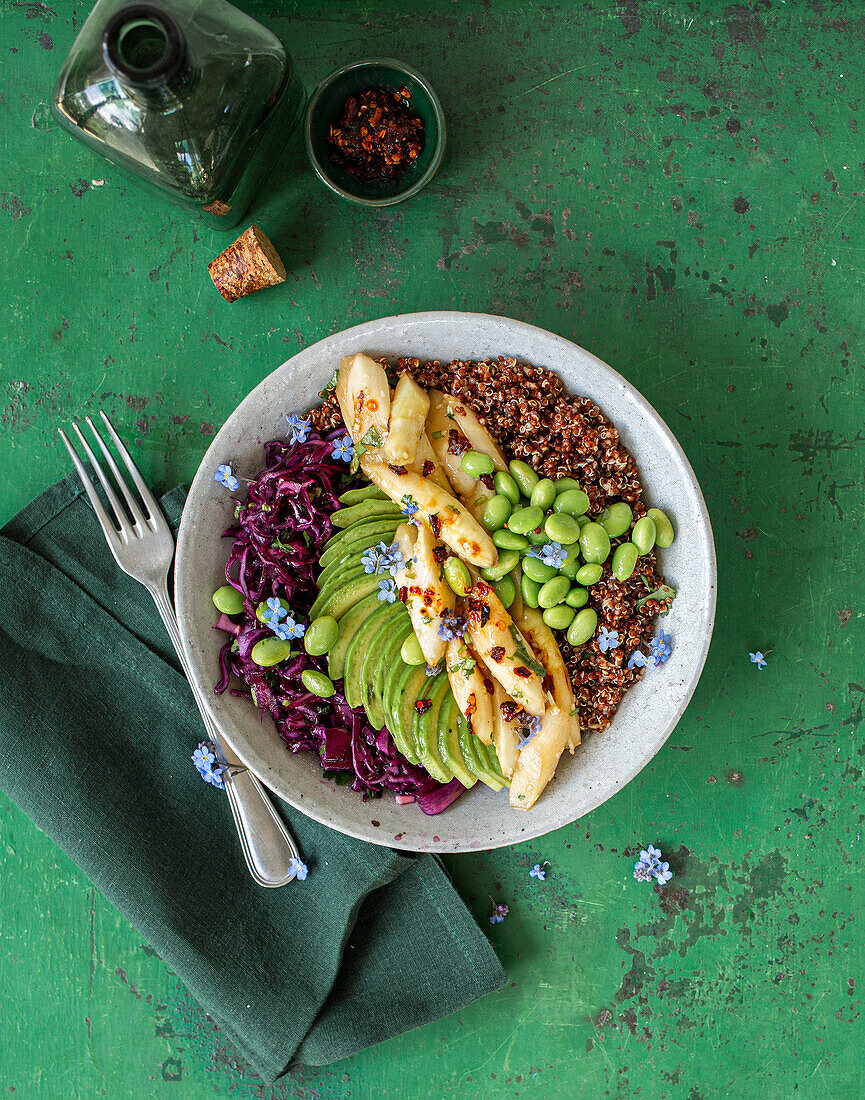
59, 409, 299, 887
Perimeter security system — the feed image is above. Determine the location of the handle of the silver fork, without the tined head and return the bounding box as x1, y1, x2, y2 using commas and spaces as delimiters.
150, 583, 299, 887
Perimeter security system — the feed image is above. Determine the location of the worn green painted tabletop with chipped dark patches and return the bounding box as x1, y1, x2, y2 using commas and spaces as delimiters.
0, 0, 865, 1100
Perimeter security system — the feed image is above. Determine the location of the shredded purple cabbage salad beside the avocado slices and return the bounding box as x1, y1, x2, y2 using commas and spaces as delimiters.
215, 432, 464, 814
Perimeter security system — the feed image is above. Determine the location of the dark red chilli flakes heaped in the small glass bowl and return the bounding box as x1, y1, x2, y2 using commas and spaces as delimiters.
328, 88, 424, 183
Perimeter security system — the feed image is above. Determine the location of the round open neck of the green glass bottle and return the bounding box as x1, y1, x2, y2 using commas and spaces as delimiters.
102, 3, 193, 106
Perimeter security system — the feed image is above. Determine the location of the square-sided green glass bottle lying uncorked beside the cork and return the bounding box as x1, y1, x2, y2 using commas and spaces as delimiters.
52, 0, 304, 229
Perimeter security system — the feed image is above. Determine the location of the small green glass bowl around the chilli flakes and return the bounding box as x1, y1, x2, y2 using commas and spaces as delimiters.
306, 57, 446, 207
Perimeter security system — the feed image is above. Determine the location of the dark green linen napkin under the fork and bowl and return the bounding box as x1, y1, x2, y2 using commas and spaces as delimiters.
0, 479, 505, 1082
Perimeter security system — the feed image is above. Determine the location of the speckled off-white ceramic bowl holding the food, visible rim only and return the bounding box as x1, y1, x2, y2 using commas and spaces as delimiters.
175, 312, 715, 851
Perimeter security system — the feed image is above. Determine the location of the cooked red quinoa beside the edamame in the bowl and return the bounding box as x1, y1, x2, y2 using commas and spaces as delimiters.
305, 355, 665, 729
